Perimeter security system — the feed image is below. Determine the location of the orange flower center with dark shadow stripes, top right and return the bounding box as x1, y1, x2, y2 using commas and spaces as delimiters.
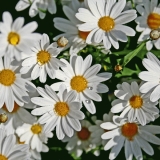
147, 13, 160, 29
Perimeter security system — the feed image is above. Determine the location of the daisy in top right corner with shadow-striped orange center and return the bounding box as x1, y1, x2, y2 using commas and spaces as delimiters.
135, 0, 160, 50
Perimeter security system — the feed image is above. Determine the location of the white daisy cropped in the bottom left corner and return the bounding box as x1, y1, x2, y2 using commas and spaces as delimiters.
0, 129, 29, 160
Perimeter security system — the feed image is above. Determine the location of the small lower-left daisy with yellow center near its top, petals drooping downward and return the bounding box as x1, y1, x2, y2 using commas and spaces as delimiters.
16, 122, 53, 152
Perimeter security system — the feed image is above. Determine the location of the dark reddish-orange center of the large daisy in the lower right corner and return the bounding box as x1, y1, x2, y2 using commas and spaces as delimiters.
121, 123, 138, 141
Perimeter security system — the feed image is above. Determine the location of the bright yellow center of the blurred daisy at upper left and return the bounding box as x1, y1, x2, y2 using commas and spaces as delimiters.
8, 32, 20, 46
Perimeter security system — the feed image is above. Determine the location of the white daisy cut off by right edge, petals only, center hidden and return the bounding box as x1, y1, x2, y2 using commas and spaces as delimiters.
139, 52, 160, 102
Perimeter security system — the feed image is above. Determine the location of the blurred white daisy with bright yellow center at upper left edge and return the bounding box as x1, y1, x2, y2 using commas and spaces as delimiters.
0, 12, 40, 61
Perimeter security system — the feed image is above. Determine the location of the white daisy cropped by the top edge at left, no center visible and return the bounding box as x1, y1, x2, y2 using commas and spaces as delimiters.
15, 0, 57, 19
